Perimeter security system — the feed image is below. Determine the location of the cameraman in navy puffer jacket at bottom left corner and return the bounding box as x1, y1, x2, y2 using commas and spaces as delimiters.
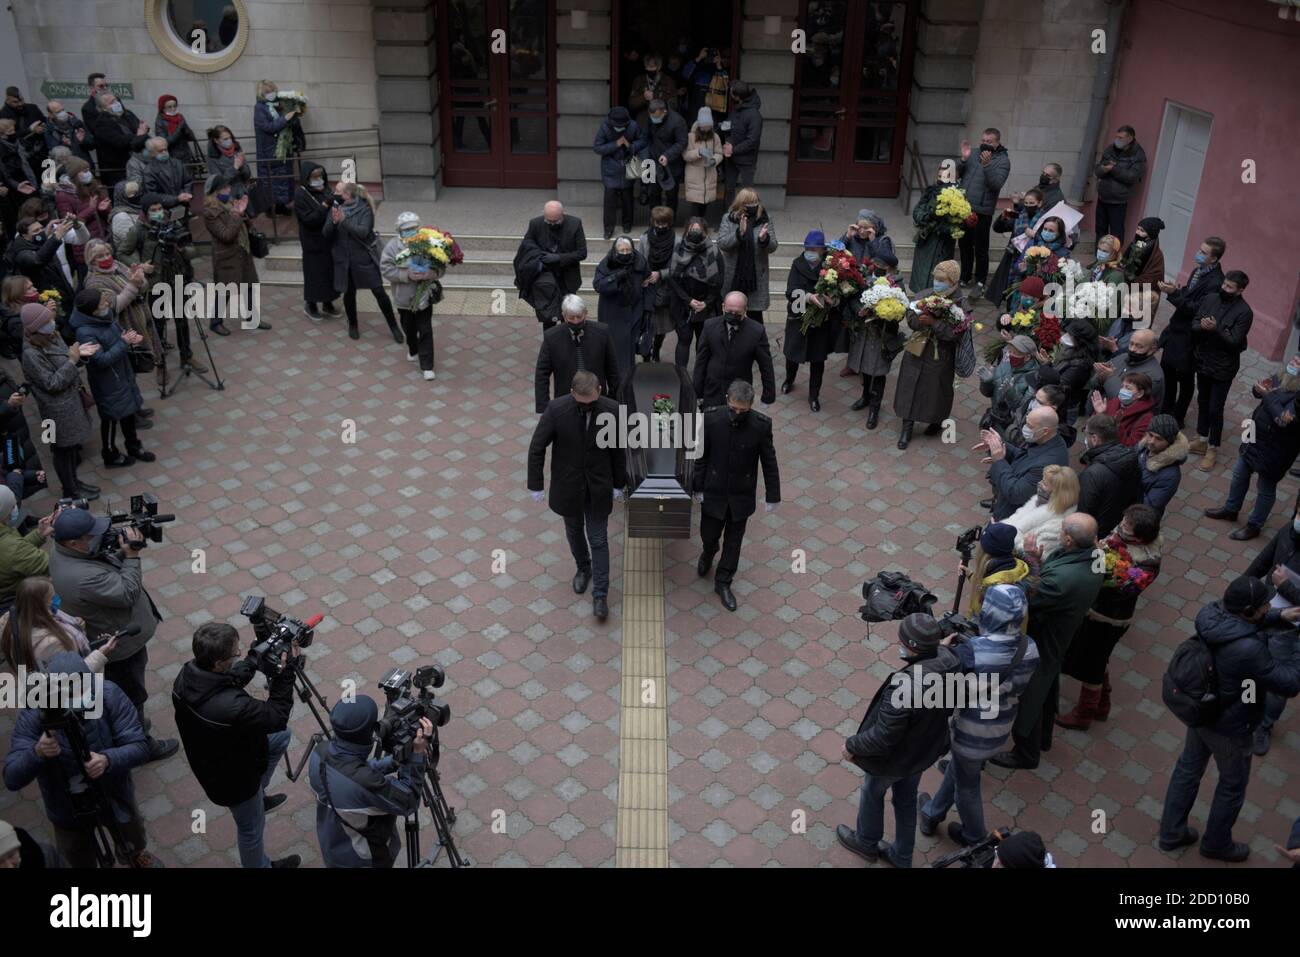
4, 651, 163, 867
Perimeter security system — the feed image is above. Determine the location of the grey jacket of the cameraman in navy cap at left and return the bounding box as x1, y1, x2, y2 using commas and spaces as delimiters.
49, 542, 163, 662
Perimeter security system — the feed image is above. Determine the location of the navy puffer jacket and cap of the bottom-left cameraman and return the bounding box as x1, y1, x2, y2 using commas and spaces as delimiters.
4, 651, 150, 828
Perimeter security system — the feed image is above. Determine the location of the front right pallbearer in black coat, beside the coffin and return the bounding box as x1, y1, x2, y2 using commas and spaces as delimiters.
694, 382, 781, 611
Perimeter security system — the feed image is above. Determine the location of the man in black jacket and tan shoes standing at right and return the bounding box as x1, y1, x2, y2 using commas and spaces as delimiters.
1187, 269, 1255, 472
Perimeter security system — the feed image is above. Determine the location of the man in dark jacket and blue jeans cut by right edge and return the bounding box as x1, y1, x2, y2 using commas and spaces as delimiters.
1205, 356, 1300, 542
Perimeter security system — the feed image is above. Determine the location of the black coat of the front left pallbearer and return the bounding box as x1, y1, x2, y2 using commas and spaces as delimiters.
528, 395, 628, 518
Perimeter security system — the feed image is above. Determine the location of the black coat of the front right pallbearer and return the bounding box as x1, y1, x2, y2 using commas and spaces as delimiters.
694, 408, 781, 519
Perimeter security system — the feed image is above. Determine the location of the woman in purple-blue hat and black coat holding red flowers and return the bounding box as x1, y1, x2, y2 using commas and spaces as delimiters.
781, 229, 862, 412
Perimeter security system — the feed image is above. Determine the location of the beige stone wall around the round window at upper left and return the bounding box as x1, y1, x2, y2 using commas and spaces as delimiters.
10, 0, 380, 179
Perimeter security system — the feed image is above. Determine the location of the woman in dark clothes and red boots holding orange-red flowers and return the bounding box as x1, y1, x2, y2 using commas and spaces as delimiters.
1056, 505, 1162, 731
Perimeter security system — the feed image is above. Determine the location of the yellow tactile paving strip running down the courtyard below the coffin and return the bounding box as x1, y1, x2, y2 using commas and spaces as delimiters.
615, 538, 668, 867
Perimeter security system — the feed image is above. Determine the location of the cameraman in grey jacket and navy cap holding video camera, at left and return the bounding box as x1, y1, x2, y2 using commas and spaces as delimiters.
49, 508, 179, 761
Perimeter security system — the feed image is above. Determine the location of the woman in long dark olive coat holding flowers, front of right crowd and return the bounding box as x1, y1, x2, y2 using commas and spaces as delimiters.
894, 259, 970, 449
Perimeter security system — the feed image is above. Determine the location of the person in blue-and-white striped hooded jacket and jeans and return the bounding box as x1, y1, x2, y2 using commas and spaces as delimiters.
918, 585, 1039, 846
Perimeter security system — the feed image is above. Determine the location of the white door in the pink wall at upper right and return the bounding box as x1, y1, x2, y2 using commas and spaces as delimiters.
1147, 103, 1213, 278
